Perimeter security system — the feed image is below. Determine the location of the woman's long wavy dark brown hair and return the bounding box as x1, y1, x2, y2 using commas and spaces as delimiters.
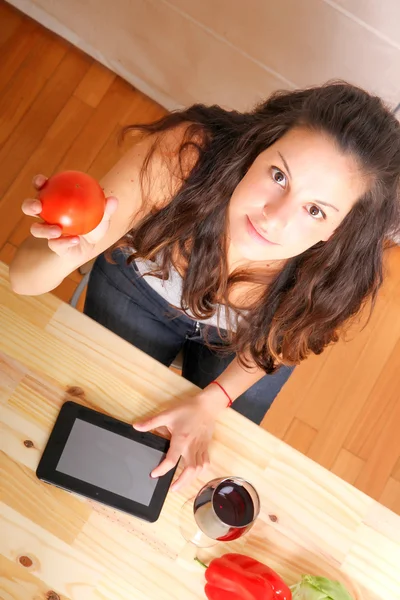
109, 81, 400, 373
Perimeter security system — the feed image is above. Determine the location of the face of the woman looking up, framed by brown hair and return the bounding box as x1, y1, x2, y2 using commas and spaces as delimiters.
229, 127, 366, 262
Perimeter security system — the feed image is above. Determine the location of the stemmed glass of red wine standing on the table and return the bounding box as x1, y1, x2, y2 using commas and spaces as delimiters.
180, 477, 260, 548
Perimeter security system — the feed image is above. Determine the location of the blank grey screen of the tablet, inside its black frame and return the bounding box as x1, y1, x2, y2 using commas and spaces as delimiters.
56, 419, 165, 506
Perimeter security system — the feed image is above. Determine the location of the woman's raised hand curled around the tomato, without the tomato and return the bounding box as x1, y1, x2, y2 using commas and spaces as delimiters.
22, 175, 118, 258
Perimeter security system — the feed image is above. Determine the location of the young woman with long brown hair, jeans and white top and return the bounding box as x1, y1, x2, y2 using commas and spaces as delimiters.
10, 82, 400, 489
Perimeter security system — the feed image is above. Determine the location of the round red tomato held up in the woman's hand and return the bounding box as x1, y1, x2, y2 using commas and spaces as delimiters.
38, 171, 106, 235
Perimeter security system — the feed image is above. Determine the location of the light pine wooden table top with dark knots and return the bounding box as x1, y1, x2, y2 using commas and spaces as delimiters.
0, 264, 400, 600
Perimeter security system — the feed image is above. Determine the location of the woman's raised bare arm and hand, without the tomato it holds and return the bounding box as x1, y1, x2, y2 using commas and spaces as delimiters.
9, 128, 188, 295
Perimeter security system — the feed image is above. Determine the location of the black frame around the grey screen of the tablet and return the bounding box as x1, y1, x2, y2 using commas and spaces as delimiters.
36, 401, 178, 523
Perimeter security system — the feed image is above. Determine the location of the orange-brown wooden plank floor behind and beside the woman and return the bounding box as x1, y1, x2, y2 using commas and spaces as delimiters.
0, 0, 400, 514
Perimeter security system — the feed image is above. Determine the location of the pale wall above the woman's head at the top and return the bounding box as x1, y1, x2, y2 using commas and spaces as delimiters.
6, 0, 400, 110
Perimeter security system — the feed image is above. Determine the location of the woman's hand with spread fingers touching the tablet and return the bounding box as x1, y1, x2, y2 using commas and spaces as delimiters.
133, 394, 218, 491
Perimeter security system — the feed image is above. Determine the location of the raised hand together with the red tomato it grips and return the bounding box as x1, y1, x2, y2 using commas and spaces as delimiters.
22, 171, 118, 258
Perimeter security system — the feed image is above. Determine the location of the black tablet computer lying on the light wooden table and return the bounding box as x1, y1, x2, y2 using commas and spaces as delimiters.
36, 402, 177, 522
